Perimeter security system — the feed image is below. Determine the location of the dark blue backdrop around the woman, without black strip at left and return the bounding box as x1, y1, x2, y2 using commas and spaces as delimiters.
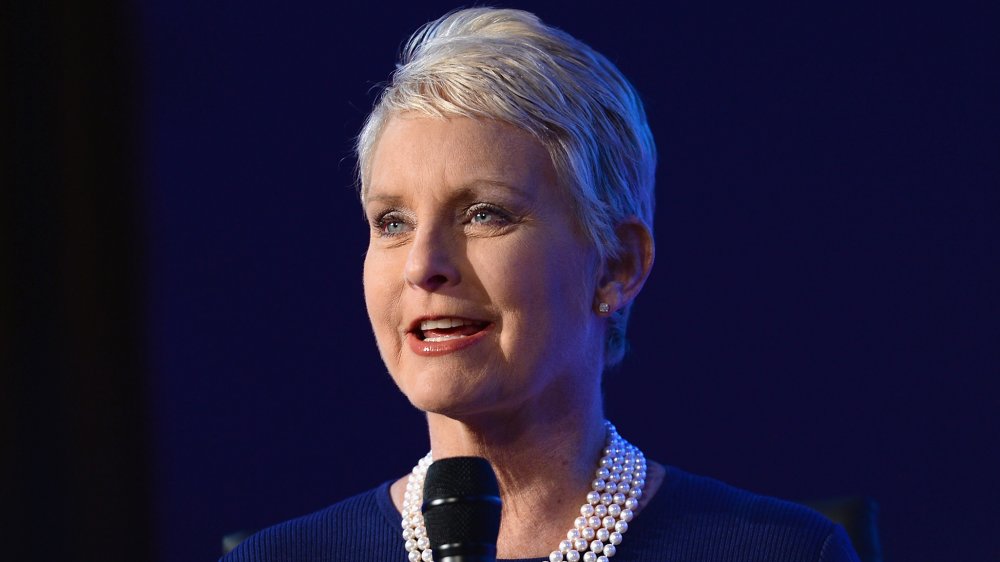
140, 0, 1000, 562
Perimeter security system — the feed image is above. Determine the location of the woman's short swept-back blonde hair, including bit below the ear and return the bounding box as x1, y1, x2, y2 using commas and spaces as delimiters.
357, 8, 656, 365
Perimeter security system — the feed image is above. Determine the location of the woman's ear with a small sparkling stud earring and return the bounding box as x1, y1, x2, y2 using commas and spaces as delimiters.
594, 217, 655, 315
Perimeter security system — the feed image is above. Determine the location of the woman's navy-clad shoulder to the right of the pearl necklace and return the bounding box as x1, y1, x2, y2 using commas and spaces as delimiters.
629, 467, 857, 562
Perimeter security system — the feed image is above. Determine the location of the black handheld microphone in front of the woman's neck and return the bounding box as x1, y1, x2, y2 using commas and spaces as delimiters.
421, 457, 500, 562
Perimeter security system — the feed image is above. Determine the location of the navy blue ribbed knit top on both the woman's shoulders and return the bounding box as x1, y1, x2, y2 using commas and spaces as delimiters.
222, 467, 858, 562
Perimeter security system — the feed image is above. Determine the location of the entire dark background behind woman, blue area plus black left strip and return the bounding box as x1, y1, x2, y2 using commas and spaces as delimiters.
0, 0, 1000, 562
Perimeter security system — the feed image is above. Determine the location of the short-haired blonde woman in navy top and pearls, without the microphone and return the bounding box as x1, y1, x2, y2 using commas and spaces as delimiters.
226, 9, 855, 562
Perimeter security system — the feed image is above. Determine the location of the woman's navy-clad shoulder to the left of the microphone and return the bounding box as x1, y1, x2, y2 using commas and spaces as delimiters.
220, 476, 402, 562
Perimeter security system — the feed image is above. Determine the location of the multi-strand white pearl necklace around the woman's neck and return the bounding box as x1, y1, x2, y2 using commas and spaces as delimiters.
403, 421, 646, 562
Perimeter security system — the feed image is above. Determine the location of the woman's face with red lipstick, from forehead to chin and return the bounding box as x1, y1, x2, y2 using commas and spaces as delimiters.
364, 114, 604, 416
